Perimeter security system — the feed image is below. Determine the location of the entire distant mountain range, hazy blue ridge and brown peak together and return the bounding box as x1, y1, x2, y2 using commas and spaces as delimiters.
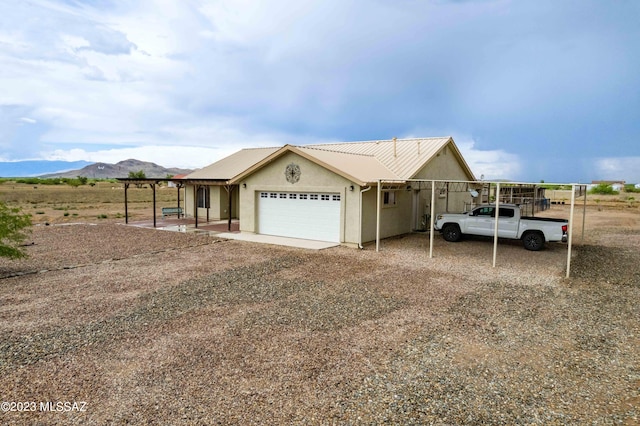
0, 159, 193, 179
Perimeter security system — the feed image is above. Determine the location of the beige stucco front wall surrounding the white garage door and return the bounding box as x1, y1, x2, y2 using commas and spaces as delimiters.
240, 152, 359, 245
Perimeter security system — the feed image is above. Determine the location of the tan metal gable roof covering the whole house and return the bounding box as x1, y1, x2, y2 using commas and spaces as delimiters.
187, 137, 475, 186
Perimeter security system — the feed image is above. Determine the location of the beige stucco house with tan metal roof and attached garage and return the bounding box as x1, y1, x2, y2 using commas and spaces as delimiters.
184, 137, 475, 246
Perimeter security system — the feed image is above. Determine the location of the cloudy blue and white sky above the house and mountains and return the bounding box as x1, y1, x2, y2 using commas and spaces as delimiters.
0, 0, 640, 182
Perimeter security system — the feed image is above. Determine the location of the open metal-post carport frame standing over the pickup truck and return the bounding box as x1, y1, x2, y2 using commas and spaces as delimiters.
376, 179, 587, 278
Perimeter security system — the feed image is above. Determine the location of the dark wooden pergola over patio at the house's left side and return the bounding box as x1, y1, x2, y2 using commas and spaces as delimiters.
117, 178, 238, 231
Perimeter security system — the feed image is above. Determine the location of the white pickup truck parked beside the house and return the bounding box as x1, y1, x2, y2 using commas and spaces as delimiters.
434, 204, 568, 250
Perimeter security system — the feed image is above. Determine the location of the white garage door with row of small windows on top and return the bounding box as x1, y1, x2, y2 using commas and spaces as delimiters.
258, 192, 340, 243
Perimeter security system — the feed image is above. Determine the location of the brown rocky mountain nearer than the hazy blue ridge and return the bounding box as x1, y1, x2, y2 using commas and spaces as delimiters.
40, 159, 193, 179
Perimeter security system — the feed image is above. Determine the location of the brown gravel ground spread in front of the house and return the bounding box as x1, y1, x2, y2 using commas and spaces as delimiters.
0, 206, 640, 425
